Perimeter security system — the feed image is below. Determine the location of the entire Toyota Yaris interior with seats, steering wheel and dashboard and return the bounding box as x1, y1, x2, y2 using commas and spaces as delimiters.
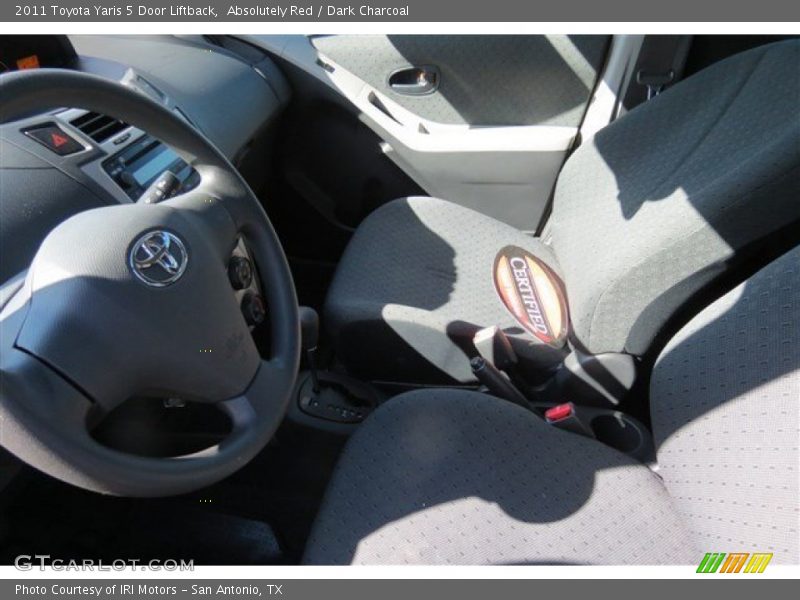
0, 35, 800, 565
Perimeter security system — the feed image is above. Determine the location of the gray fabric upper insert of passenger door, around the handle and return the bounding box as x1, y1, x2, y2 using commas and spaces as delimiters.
311, 35, 608, 127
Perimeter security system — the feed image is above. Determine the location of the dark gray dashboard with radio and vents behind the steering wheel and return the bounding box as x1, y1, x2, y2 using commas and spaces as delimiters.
0, 35, 289, 287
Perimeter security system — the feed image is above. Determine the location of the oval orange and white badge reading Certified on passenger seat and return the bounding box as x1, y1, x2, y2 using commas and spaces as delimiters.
494, 246, 569, 347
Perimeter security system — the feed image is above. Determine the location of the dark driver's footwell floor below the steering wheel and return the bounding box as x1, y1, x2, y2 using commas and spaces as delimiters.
0, 426, 343, 565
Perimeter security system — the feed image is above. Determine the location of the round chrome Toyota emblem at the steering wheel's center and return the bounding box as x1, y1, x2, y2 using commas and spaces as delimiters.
128, 230, 189, 287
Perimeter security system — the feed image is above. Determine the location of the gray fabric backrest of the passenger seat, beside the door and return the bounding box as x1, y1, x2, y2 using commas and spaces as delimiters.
549, 40, 800, 354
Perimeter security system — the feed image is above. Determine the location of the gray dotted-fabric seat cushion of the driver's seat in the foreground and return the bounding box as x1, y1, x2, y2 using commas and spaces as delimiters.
305, 390, 698, 564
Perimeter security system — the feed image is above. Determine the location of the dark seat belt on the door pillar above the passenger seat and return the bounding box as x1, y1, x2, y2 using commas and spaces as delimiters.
622, 35, 692, 111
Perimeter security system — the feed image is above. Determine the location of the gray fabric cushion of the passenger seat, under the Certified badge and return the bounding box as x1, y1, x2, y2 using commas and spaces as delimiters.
325, 198, 563, 382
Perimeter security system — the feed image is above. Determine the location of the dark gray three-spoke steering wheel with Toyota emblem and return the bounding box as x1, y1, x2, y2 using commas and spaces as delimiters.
0, 69, 300, 496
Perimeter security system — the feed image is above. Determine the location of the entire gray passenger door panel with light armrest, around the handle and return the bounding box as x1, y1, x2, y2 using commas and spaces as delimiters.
248, 35, 609, 231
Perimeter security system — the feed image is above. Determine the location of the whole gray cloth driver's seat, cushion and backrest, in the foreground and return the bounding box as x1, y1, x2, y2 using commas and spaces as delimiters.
305, 248, 800, 565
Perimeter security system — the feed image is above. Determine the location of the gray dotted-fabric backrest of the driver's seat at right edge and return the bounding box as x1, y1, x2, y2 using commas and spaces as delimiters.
651, 244, 800, 564
